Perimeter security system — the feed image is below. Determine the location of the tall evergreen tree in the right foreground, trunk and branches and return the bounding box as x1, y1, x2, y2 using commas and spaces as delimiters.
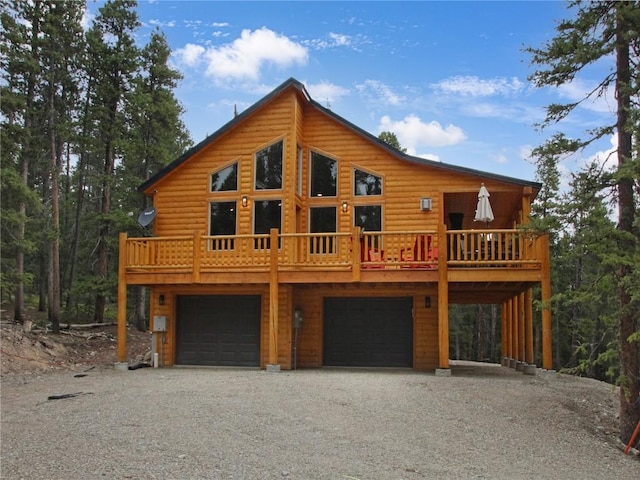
527, 0, 640, 442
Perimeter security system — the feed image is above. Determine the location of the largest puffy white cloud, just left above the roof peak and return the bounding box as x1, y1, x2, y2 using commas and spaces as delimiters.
204, 27, 308, 81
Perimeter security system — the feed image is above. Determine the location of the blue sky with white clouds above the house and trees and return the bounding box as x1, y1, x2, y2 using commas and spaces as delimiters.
87, 0, 615, 184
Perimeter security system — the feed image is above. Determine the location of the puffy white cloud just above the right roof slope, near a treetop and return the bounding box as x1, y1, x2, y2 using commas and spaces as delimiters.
378, 115, 467, 148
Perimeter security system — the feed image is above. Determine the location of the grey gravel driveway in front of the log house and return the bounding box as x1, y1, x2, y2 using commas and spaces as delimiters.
0, 364, 640, 480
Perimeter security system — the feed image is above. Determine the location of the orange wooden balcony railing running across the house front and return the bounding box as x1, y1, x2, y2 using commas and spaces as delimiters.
124, 229, 542, 272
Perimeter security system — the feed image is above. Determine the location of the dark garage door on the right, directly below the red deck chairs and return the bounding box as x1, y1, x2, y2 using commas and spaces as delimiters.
323, 297, 413, 367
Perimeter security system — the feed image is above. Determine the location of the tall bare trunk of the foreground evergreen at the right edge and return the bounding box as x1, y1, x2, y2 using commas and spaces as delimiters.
616, 3, 640, 444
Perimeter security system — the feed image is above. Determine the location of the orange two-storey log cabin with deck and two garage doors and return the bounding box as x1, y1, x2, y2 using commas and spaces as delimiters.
118, 79, 551, 371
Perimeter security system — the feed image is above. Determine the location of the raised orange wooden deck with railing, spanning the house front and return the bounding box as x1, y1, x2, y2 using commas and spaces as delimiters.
120, 228, 545, 285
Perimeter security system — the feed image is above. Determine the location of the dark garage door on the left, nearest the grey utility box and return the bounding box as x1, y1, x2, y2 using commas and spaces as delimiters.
176, 295, 260, 367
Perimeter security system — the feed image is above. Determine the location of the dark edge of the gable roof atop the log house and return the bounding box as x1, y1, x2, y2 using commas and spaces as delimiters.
138, 78, 542, 193
